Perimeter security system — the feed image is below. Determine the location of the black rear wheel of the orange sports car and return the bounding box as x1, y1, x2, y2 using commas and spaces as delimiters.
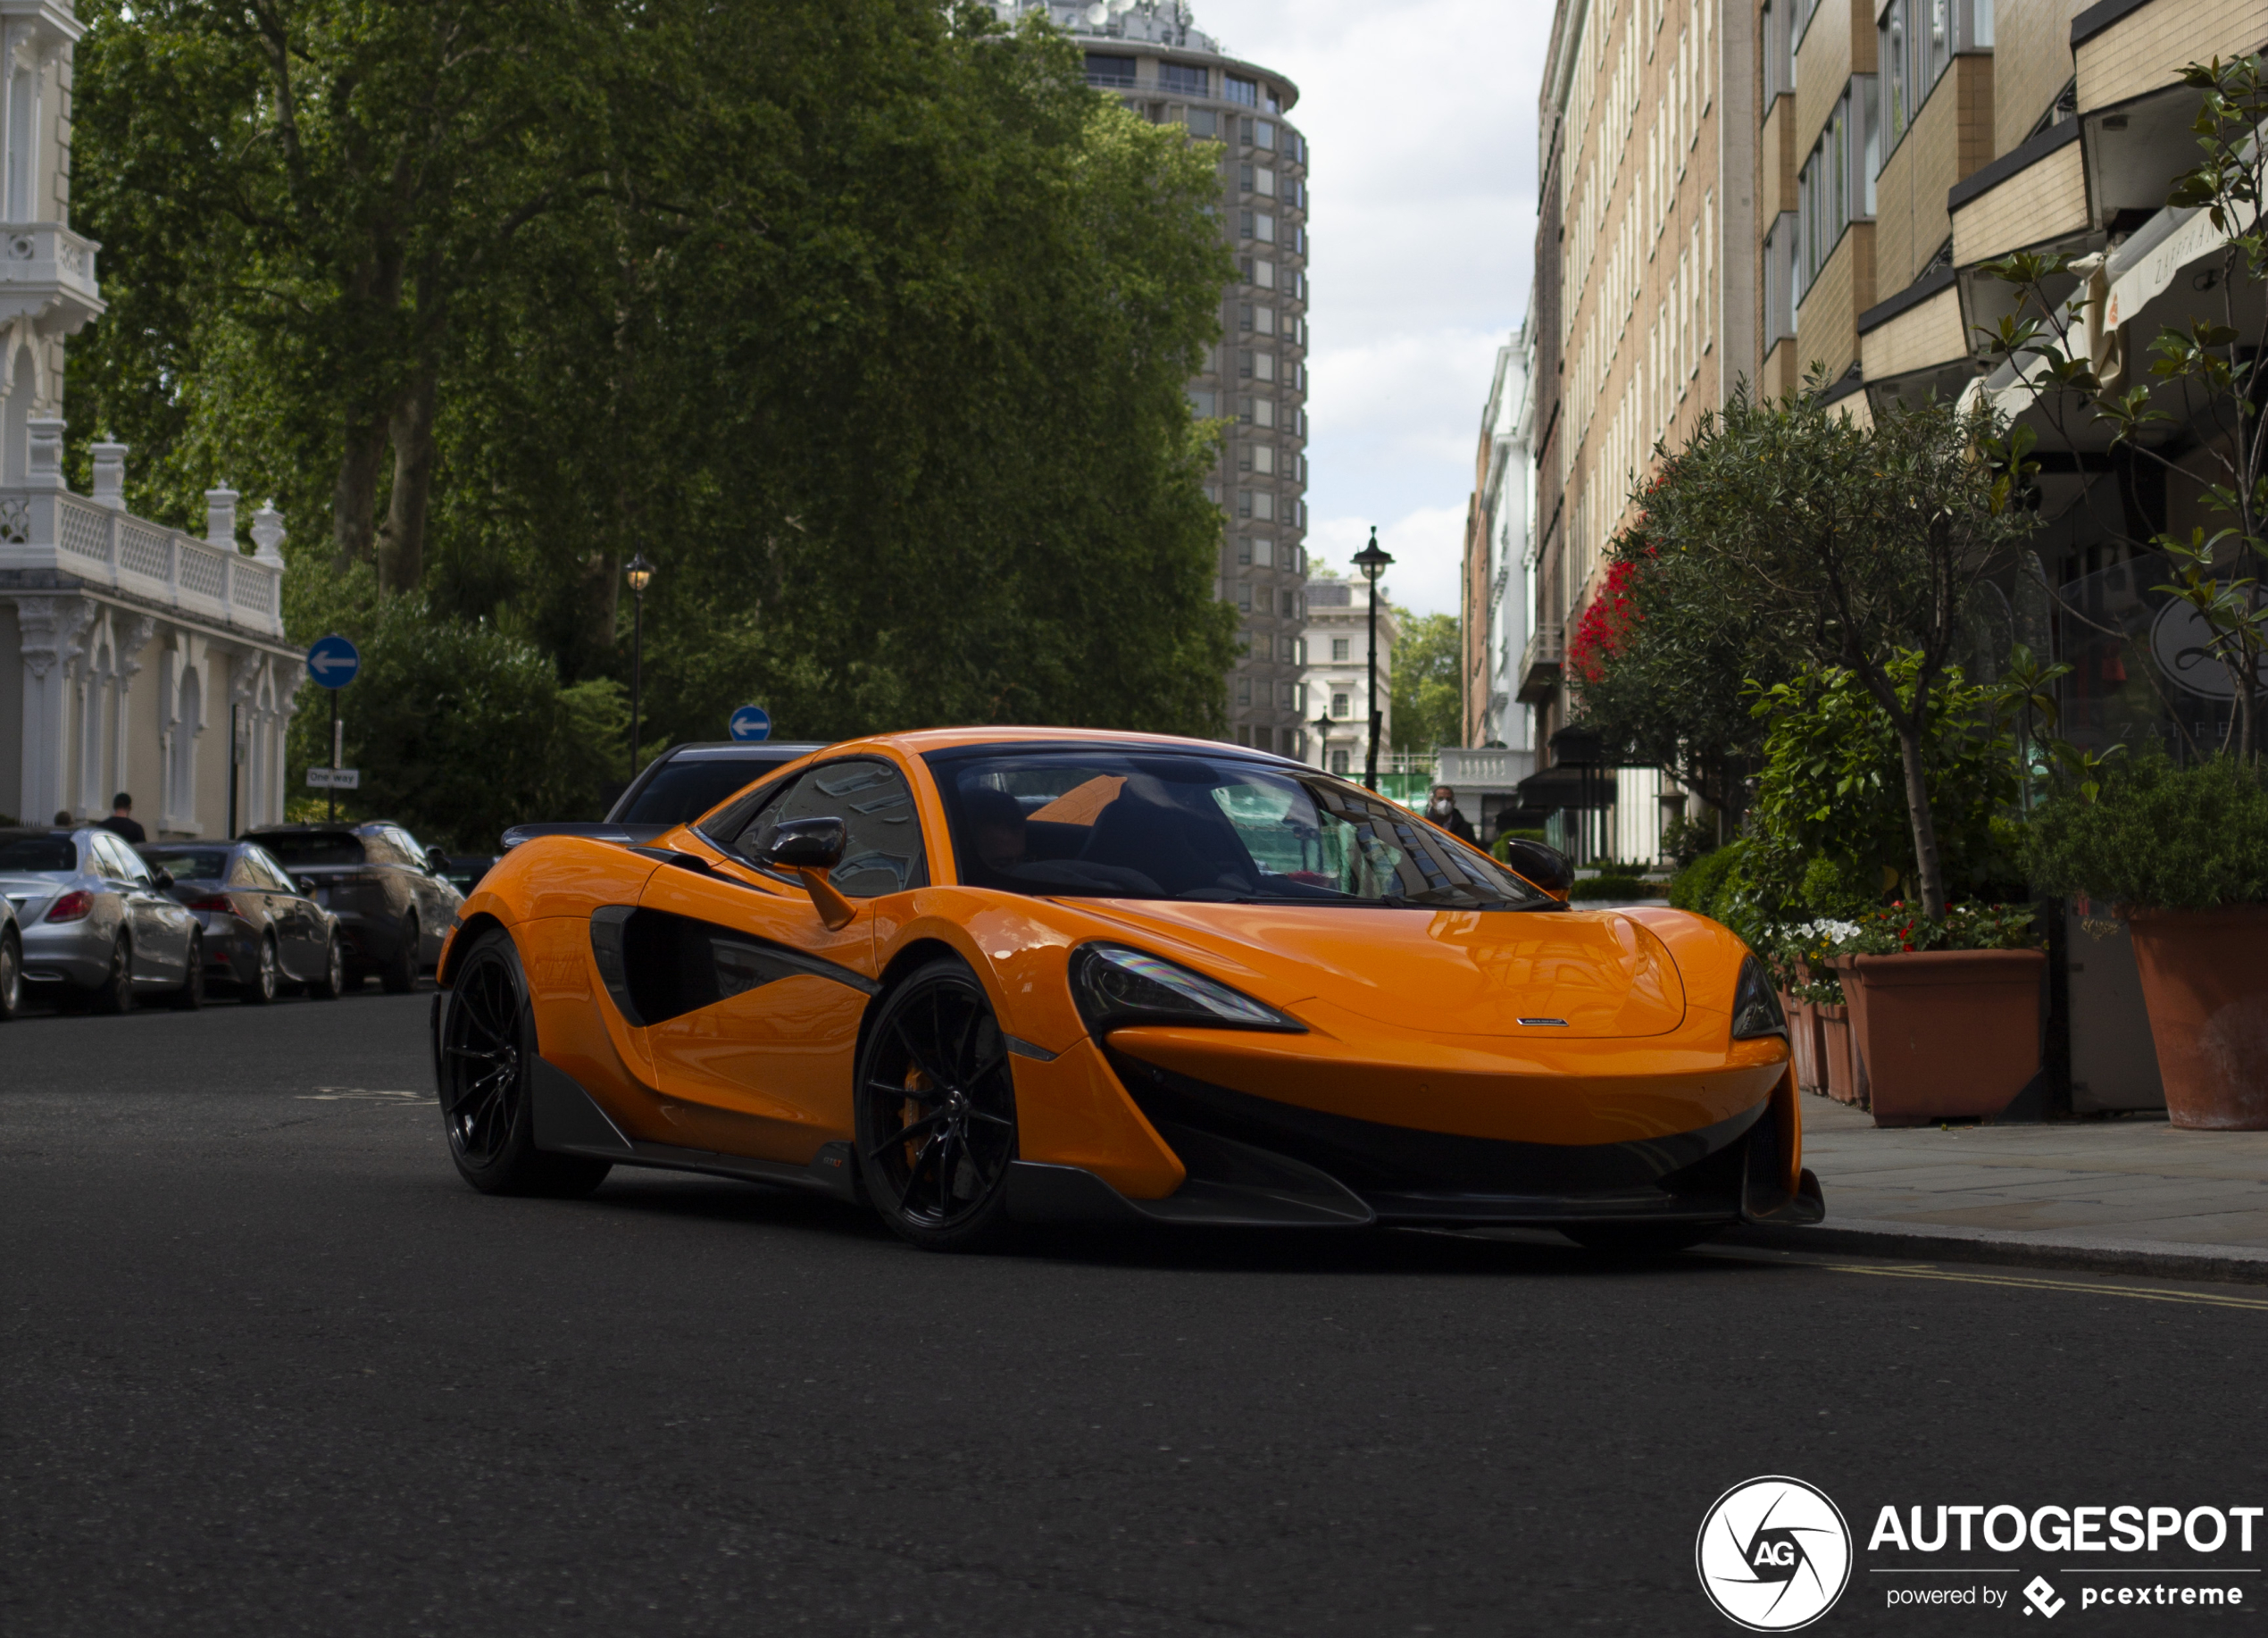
438, 928, 613, 1196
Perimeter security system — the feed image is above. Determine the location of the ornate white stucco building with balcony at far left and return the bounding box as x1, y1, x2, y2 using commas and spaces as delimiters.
0, 0, 306, 837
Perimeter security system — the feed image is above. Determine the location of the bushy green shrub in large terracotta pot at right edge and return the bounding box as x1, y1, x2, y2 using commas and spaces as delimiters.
2030, 747, 2268, 1132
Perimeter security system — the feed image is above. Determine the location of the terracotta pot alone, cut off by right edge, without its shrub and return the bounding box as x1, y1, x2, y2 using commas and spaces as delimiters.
2128, 906, 2268, 1132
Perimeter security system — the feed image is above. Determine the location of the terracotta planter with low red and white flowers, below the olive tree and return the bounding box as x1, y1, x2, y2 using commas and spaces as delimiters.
1828, 903, 2048, 1125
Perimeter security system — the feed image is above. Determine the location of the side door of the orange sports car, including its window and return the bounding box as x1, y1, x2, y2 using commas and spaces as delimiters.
630, 757, 925, 1164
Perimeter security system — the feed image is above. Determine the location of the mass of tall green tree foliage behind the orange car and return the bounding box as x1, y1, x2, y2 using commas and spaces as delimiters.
71, 0, 1236, 766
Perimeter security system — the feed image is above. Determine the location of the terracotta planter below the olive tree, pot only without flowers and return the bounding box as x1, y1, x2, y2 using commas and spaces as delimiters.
1835, 950, 2048, 1125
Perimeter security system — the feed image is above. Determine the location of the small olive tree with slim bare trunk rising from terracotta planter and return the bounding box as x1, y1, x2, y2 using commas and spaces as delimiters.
1647, 379, 2032, 916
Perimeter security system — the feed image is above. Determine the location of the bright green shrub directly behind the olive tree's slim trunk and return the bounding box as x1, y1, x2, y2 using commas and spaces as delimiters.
1747, 656, 2021, 916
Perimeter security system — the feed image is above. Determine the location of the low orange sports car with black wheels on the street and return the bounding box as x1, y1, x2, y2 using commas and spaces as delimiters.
433, 728, 1822, 1250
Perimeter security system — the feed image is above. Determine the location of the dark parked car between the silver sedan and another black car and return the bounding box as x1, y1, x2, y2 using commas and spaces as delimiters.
138, 841, 347, 1005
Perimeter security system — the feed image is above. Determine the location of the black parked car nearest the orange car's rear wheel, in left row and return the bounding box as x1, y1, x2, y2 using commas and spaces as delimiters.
245, 819, 465, 994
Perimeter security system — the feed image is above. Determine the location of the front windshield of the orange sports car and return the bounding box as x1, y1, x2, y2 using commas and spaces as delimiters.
930, 748, 1554, 910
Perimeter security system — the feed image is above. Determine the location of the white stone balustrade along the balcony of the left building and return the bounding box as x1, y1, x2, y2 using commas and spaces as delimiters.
0, 488, 284, 638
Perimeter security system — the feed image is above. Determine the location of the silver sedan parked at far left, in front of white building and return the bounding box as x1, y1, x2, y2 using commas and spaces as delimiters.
0, 826, 204, 1012
